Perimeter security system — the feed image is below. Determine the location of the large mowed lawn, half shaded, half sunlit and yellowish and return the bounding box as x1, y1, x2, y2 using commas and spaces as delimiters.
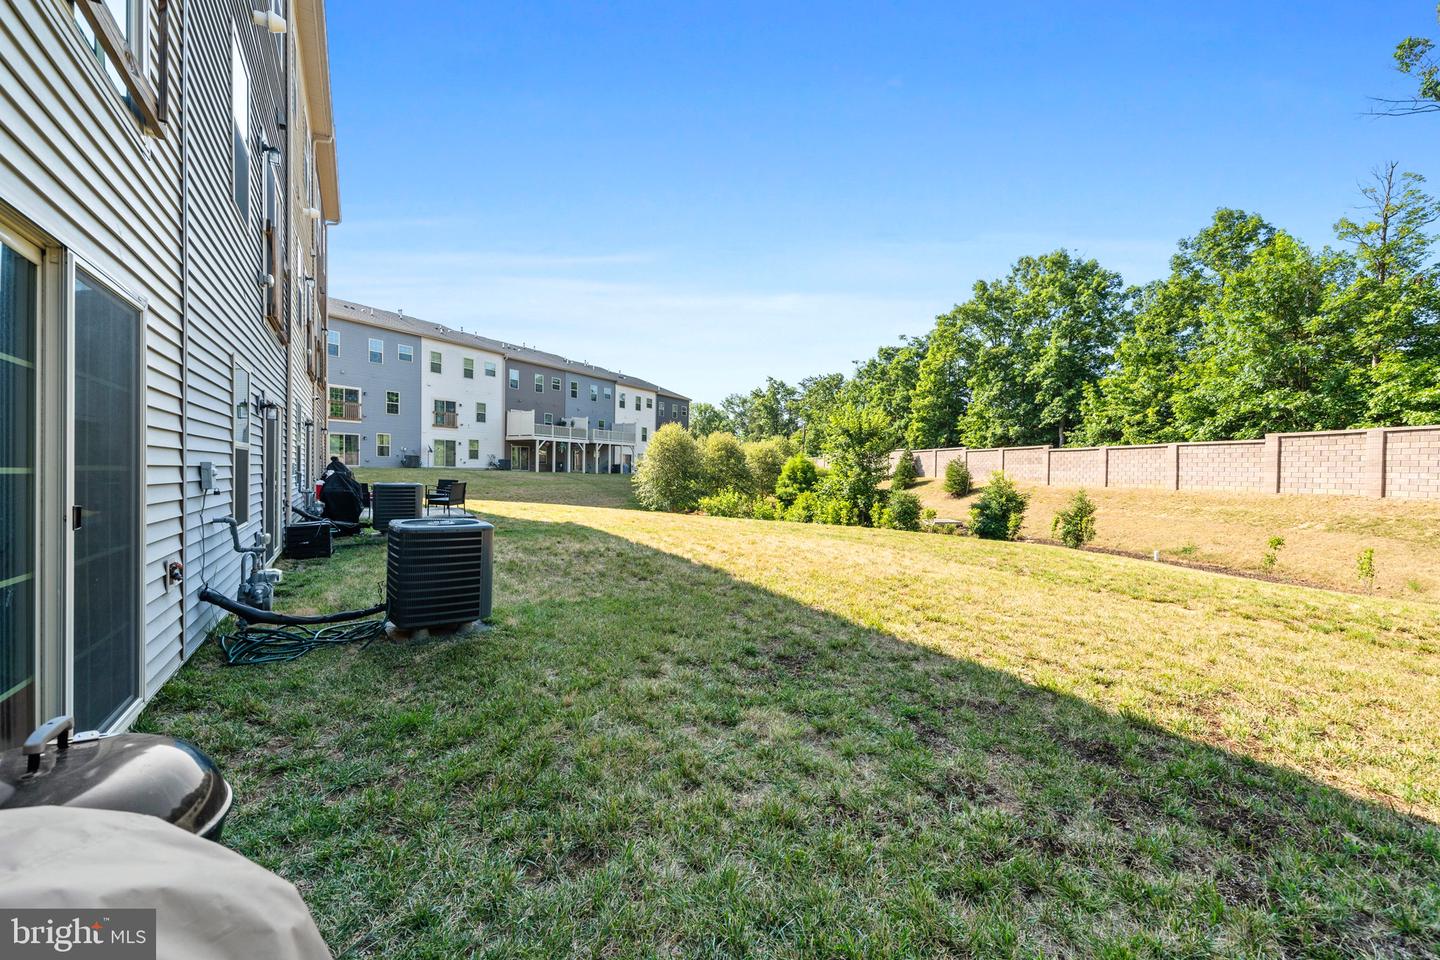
141, 475, 1440, 957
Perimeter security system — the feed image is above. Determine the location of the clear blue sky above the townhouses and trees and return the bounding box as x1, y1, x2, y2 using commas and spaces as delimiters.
328, 0, 1440, 402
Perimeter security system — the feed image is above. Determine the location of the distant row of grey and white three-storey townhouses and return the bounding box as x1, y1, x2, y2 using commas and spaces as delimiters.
327, 298, 690, 474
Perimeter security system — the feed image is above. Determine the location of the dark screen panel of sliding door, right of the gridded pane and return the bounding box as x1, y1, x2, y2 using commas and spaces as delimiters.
71, 266, 145, 730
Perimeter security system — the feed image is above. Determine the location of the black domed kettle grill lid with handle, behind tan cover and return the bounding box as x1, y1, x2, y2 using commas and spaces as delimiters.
0, 717, 232, 841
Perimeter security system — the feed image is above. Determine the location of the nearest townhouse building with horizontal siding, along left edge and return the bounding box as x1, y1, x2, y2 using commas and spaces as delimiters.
0, 0, 340, 747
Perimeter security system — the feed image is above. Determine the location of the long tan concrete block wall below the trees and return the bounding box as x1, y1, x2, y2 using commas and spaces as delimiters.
892, 426, 1440, 499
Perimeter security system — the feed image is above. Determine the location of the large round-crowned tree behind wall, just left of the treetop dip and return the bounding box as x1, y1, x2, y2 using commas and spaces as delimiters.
959, 250, 1133, 446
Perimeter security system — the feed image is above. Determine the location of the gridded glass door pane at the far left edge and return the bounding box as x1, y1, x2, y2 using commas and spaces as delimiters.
0, 233, 39, 748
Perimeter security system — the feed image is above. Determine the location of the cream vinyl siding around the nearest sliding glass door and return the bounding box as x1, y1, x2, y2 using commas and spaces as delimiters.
0, 0, 181, 697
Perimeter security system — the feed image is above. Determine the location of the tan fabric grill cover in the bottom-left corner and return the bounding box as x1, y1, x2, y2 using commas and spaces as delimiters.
0, 806, 330, 960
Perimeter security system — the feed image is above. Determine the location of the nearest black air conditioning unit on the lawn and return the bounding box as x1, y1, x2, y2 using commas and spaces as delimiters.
386, 517, 495, 630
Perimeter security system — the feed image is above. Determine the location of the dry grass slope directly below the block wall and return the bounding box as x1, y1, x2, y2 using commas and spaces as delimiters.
913, 479, 1440, 602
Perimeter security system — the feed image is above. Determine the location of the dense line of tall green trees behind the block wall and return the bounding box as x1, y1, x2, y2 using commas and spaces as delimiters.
691, 164, 1440, 453
